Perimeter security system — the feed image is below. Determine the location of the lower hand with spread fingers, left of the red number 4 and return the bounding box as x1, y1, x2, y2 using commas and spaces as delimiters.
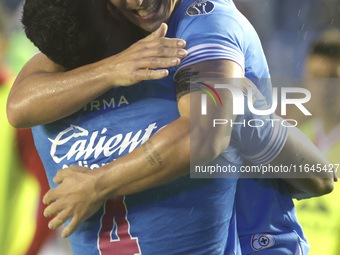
43, 166, 105, 237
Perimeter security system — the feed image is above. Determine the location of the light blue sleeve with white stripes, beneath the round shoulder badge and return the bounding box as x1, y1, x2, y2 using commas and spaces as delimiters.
176, 1, 247, 70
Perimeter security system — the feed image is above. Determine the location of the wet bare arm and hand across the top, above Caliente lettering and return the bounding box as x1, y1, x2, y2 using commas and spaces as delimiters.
7, 24, 186, 128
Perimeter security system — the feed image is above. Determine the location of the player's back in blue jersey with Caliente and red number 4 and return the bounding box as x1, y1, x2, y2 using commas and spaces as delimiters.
33, 73, 236, 255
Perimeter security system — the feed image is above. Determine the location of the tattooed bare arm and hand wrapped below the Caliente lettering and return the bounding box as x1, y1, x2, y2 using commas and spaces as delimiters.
44, 60, 243, 236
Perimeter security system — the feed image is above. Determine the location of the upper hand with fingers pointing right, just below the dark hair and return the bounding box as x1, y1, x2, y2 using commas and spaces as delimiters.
105, 23, 187, 86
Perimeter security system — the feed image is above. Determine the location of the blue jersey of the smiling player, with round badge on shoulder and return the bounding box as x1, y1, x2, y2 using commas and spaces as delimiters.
169, 0, 309, 255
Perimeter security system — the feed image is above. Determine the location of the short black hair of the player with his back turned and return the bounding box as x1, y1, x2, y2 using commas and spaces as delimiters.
22, 0, 145, 69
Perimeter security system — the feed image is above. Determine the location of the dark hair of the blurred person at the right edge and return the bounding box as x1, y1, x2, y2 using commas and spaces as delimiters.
310, 28, 340, 60
